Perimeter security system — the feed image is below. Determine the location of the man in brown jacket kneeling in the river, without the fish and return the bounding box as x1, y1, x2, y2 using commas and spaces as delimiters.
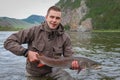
4, 6, 79, 80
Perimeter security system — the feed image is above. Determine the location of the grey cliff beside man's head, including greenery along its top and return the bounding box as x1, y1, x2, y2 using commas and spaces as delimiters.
57, 0, 91, 30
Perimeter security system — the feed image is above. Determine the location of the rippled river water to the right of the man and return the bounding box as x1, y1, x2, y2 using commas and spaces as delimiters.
70, 32, 120, 80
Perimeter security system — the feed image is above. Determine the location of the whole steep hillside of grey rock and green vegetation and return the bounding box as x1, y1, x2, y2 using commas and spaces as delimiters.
56, 0, 120, 31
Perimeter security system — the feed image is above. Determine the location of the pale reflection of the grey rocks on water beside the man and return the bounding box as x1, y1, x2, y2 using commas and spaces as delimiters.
69, 32, 91, 49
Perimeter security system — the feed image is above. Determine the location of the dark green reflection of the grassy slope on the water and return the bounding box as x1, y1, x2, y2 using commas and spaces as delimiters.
91, 32, 120, 52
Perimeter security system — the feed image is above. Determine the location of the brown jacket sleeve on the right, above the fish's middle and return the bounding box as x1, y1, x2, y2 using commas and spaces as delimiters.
63, 35, 74, 57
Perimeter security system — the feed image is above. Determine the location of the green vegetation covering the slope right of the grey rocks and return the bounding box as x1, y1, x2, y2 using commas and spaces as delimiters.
86, 0, 120, 30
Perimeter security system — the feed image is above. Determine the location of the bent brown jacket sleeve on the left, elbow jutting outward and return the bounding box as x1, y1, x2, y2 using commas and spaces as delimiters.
4, 28, 34, 56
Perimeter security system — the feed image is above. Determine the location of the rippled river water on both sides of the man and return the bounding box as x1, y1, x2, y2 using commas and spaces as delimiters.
0, 32, 120, 80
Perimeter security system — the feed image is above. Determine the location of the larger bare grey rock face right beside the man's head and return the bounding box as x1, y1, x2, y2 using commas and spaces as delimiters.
62, 0, 88, 31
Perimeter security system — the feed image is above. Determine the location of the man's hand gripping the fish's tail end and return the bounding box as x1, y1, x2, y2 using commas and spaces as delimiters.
27, 50, 39, 62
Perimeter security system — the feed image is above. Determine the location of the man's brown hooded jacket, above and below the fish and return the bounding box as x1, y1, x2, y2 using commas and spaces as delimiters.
4, 22, 73, 75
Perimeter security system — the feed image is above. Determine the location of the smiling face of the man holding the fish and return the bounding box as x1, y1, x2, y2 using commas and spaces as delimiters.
46, 10, 61, 29
